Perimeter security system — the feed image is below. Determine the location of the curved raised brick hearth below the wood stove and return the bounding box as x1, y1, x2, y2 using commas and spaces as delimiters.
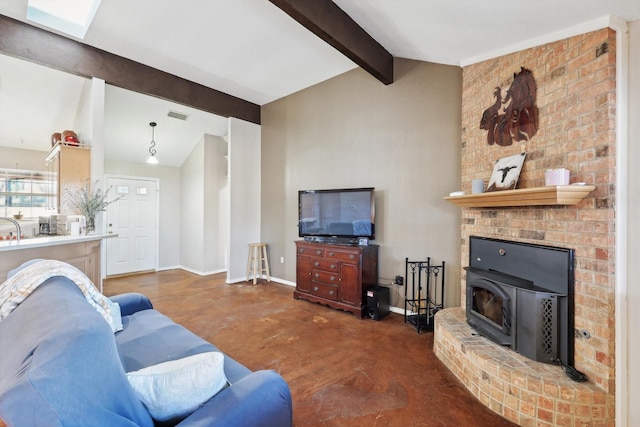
434, 307, 615, 427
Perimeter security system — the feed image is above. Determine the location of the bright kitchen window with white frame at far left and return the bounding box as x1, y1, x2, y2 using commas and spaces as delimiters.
0, 169, 57, 218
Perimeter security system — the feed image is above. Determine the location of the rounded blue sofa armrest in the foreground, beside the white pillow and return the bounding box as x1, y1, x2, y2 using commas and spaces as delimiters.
176, 371, 293, 427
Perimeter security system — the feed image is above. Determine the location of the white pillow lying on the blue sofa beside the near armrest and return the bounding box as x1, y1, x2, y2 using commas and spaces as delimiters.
127, 351, 227, 421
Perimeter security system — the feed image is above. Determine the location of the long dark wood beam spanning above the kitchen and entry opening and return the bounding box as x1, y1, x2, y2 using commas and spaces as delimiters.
0, 15, 260, 124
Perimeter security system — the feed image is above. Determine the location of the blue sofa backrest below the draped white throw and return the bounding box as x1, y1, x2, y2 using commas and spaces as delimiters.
0, 277, 153, 426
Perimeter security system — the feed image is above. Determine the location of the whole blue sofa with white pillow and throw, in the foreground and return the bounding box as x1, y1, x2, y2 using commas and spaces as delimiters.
0, 276, 292, 427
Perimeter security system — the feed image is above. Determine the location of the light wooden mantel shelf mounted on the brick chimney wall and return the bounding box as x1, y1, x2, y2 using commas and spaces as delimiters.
444, 185, 596, 208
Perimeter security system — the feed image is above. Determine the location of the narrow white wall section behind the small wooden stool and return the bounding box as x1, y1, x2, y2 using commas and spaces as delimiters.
227, 118, 262, 283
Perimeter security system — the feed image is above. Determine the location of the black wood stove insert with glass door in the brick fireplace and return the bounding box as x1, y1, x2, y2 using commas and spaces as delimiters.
465, 236, 574, 367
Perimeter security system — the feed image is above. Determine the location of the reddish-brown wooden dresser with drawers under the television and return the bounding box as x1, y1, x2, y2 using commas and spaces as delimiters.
293, 241, 378, 318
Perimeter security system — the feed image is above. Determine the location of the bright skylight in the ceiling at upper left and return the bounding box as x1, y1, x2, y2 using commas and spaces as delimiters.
27, 0, 100, 39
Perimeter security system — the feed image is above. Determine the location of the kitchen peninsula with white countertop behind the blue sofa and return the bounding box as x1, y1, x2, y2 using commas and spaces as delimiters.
0, 234, 118, 292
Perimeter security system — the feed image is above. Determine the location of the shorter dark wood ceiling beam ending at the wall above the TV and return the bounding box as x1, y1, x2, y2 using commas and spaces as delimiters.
269, 0, 393, 85
